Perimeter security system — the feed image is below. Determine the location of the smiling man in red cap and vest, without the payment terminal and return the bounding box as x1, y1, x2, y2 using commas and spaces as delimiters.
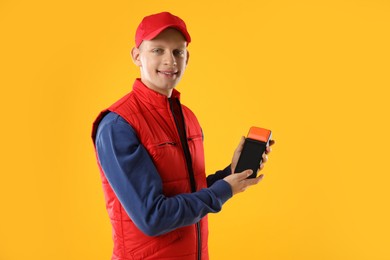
92, 12, 270, 260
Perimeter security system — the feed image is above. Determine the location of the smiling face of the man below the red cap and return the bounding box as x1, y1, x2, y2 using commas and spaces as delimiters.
132, 28, 189, 97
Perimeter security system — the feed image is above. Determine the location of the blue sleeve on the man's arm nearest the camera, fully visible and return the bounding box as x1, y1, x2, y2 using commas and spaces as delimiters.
95, 112, 232, 236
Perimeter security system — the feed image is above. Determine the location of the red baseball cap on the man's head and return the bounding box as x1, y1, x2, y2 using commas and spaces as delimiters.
135, 12, 191, 48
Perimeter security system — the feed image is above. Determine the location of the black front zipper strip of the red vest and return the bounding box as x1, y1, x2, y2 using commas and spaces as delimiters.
168, 98, 202, 260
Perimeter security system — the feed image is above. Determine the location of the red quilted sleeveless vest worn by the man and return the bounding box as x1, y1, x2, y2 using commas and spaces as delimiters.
92, 79, 208, 260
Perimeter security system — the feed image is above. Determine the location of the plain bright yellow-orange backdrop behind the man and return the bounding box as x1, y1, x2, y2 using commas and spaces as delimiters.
0, 0, 390, 260
